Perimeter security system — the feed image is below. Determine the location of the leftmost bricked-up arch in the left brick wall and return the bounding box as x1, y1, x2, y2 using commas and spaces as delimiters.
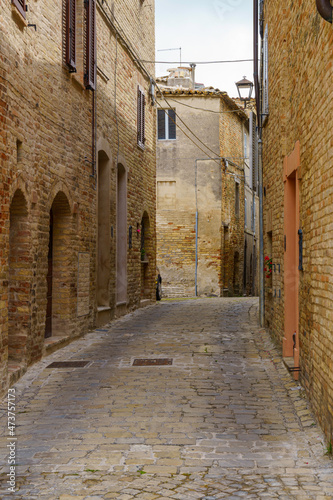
8, 188, 32, 364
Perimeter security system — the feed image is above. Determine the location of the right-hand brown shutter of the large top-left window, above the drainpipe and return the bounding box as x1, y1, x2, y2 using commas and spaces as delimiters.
84, 0, 96, 90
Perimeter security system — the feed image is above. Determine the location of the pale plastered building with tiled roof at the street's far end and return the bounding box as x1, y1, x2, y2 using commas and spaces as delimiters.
157, 67, 258, 297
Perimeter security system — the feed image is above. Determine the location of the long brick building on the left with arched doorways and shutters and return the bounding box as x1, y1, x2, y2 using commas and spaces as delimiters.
0, 0, 156, 393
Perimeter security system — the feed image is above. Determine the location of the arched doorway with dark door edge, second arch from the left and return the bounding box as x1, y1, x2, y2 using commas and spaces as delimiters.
45, 191, 74, 338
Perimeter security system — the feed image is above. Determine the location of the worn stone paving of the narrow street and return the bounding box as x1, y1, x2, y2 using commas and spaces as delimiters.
0, 298, 333, 500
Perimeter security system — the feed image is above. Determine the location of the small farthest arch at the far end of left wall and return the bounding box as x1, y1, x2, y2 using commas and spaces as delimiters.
140, 210, 153, 299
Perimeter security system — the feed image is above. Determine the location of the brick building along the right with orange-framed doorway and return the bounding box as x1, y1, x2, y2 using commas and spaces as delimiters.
260, 0, 333, 446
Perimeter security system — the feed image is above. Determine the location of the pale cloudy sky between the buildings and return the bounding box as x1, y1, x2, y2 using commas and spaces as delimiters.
155, 0, 253, 97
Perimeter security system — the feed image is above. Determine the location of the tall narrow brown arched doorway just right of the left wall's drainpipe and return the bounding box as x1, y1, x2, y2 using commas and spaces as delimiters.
96, 146, 111, 308
